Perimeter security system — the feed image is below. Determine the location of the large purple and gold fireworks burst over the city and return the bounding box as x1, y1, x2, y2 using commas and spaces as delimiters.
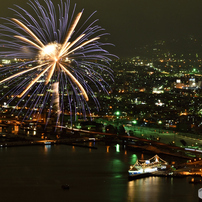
0, 0, 112, 126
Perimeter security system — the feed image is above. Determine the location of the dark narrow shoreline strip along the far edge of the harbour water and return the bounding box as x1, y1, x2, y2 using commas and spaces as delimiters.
0, 136, 202, 160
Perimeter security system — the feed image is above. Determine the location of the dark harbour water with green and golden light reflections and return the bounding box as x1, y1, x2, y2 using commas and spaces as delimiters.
0, 145, 201, 202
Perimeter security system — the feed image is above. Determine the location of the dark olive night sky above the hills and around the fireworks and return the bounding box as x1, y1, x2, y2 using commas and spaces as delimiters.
0, 0, 202, 57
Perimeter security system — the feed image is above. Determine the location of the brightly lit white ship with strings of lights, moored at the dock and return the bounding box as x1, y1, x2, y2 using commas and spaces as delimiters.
128, 155, 168, 178
